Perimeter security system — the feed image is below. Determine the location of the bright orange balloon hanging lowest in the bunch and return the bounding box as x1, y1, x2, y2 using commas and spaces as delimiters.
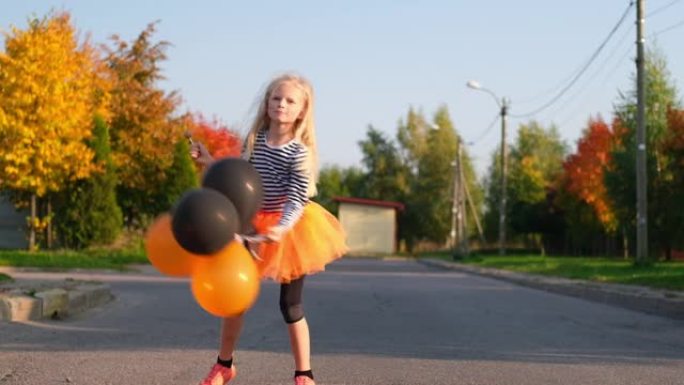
191, 241, 259, 317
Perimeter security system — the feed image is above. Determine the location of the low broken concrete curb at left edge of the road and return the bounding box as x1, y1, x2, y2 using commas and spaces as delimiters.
0, 280, 114, 322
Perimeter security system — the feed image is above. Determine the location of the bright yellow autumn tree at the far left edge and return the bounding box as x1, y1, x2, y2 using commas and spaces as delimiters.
0, 12, 108, 248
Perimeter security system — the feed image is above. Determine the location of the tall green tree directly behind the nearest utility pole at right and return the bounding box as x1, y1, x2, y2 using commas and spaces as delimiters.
605, 49, 681, 255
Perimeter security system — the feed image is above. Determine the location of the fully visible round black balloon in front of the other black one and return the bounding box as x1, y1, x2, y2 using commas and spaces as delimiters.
171, 188, 240, 255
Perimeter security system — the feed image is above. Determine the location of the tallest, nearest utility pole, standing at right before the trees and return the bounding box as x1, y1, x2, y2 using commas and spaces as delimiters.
636, 0, 648, 264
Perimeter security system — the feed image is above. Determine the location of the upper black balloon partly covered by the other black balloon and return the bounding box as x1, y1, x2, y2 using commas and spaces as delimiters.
202, 158, 264, 234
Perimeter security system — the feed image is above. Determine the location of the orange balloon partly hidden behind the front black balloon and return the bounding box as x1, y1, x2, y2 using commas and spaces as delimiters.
145, 213, 202, 277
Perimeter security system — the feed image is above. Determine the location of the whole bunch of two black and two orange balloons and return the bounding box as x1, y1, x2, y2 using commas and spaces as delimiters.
145, 158, 263, 317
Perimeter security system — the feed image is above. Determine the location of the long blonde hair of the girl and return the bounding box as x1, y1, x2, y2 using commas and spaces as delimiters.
243, 73, 318, 197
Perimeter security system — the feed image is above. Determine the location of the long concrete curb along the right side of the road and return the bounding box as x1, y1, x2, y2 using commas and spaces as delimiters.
419, 259, 684, 320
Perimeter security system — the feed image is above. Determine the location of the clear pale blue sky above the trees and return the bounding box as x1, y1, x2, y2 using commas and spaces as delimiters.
0, 0, 684, 175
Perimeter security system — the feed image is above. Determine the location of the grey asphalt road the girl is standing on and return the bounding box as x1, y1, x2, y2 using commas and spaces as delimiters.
0, 259, 684, 385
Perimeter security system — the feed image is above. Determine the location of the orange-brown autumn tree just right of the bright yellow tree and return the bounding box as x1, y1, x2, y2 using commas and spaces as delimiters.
107, 24, 184, 225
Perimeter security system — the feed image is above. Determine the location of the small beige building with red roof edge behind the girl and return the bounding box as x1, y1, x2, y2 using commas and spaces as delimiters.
333, 197, 404, 254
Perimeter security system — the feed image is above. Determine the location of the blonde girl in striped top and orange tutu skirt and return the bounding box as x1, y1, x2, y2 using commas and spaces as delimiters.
191, 74, 347, 385
